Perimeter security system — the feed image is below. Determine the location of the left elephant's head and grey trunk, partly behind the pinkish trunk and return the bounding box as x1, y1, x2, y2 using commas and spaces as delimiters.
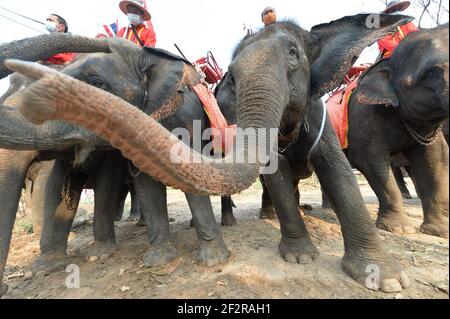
0, 34, 198, 150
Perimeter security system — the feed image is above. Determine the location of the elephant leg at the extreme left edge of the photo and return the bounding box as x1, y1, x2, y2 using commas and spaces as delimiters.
0, 150, 31, 297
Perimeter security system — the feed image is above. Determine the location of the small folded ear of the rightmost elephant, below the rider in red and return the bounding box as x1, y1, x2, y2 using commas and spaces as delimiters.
356, 60, 400, 107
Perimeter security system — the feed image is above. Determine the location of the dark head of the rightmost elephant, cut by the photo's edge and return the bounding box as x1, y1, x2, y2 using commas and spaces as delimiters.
357, 24, 449, 125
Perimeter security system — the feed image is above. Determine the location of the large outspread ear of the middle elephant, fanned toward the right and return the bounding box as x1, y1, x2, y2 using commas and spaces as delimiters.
310, 14, 413, 99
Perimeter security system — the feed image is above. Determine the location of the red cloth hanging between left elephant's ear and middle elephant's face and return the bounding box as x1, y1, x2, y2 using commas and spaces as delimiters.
192, 83, 237, 154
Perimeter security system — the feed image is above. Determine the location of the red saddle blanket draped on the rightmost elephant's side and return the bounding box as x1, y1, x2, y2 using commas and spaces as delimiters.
326, 65, 368, 149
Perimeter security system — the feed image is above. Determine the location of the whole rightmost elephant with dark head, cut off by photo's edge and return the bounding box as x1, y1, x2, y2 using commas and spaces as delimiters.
340, 24, 449, 238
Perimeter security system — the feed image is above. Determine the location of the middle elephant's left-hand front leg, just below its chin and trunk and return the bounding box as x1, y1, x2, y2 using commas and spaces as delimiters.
264, 156, 319, 264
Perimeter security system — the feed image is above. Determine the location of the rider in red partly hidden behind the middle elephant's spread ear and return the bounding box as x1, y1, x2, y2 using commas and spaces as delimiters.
378, 0, 419, 60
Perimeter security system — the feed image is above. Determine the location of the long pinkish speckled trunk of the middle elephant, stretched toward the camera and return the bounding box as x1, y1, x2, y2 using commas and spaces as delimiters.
5, 60, 280, 196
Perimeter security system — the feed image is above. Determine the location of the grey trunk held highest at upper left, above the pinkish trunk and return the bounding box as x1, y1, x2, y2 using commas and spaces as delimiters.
0, 33, 111, 79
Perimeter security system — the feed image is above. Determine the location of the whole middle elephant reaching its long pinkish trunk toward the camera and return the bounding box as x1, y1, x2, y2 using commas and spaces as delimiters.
4, 14, 411, 292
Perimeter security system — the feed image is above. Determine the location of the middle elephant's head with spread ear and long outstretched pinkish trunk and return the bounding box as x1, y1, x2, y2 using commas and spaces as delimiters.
5, 15, 410, 195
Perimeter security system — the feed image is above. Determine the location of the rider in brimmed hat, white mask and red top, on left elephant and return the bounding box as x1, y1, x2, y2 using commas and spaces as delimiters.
117, 0, 156, 48
